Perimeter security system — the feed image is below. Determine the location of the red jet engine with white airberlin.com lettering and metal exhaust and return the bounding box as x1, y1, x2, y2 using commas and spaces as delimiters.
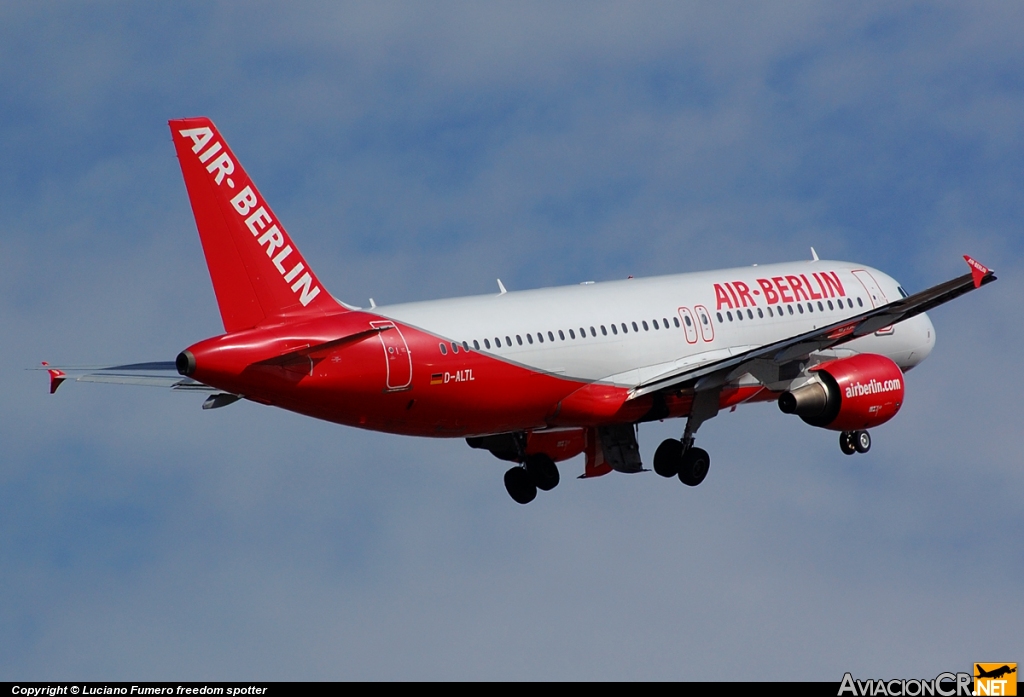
778, 353, 903, 431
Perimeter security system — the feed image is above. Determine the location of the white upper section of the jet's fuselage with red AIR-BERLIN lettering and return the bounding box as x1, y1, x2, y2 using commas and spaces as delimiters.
376, 261, 935, 386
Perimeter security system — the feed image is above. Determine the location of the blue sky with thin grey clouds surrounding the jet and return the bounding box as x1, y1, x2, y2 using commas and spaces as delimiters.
0, 2, 1024, 681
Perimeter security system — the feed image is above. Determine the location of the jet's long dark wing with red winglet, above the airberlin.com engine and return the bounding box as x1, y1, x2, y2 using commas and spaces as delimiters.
629, 255, 995, 399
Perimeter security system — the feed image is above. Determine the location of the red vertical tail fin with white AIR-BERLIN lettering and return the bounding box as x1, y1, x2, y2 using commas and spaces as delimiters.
169, 118, 344, 332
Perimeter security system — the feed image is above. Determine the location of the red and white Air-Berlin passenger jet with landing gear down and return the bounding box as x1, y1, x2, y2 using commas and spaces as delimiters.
40, 118, 995, 504
